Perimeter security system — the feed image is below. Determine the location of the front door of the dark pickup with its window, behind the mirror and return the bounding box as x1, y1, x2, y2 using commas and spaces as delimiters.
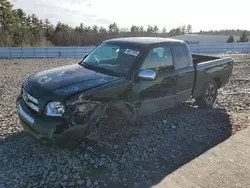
134, 45, 177, 115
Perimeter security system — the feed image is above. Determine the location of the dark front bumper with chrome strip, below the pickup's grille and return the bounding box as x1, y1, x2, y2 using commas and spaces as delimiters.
17, 98, 67, 144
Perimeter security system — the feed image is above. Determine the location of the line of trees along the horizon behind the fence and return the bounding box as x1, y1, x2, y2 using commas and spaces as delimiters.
0, 0, 249, 47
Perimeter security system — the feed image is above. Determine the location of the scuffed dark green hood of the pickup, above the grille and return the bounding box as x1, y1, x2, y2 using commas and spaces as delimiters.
24, 64, 120, 97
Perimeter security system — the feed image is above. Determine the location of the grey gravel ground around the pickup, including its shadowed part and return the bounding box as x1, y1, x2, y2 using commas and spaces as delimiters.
0, 56, 250, 188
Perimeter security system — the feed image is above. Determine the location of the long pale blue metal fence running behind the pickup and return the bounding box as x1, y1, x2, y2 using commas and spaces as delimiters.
0, 43, 250, 58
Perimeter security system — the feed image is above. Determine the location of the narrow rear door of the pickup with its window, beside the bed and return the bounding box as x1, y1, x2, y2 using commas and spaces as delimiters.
171, 43, 195, 103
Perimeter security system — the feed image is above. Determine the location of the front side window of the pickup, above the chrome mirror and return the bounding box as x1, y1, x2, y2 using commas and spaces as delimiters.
141, 46, 174, 72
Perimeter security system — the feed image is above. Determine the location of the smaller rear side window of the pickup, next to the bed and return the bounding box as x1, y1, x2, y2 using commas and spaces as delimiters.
172, 44, 190, 70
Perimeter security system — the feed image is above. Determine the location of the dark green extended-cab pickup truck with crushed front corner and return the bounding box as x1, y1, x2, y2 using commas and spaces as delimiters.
17, 37, 233, 143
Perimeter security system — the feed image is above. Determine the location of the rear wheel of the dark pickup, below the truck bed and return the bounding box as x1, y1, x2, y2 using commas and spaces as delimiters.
195, 80, 218, 108
